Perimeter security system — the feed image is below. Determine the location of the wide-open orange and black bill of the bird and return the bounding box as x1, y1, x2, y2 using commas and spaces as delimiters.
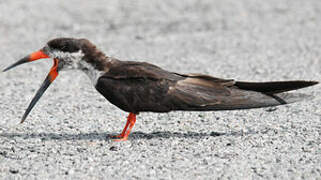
3, 50, 59, 123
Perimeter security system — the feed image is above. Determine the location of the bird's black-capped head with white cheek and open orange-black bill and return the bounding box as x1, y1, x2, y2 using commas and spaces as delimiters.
3, 38, 99, 123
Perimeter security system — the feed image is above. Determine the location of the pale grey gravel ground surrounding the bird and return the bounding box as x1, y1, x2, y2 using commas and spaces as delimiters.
0, 0, 321, 179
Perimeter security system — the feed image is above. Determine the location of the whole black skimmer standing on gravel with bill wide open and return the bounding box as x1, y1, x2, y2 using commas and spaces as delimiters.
3, 38, 318, 141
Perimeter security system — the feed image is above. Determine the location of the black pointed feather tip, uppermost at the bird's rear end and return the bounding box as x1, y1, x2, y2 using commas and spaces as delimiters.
235, 81, 318, 94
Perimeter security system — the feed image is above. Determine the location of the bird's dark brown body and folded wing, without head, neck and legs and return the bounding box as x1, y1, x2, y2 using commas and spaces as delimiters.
96, 62, 316, 113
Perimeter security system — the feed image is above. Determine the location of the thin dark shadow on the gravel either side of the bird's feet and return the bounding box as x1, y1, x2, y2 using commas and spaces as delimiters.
0, 131, 257, 141
